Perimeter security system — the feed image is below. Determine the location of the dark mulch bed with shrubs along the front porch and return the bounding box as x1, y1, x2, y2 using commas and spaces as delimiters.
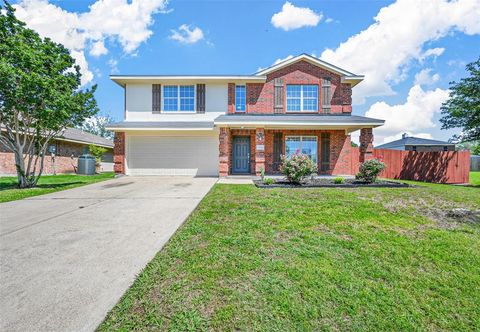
253, 178, 413, 188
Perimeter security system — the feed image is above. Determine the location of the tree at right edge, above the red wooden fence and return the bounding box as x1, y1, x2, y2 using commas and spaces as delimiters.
440, 57, 480, 142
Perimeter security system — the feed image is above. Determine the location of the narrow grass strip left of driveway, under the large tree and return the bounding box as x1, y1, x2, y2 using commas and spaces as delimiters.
0, 173, 115, 203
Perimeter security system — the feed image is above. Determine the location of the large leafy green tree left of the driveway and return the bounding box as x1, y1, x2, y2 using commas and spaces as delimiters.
0, 1, 98, 188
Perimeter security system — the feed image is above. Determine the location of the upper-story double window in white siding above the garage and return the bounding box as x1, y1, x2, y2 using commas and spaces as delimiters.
163, 85, 195, 112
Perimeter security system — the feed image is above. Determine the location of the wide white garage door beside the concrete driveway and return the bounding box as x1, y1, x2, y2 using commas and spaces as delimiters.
126, 135, 218, 176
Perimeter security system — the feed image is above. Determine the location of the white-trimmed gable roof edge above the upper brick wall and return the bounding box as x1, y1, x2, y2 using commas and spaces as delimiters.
254, 54, 363, 85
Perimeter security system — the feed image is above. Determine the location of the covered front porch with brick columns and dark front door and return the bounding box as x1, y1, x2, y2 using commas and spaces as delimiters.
216, 116, 377, 177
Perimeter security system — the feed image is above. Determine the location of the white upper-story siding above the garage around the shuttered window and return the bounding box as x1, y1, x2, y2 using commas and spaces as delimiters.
125, 82, 228, 121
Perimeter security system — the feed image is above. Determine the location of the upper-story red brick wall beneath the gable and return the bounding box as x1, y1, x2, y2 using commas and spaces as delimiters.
228, 61, 352, 114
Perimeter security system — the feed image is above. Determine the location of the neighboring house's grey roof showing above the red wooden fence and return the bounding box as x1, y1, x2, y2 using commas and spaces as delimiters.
375, 134, 455, 152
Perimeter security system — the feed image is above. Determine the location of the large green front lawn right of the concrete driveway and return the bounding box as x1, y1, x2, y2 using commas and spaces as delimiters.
98, 184, 480, 331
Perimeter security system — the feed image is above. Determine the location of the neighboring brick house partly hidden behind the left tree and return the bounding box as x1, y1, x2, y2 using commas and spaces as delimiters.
0, 128, 113, 175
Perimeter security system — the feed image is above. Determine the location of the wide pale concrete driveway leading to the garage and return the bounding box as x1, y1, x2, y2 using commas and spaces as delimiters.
0, 177, 217, 331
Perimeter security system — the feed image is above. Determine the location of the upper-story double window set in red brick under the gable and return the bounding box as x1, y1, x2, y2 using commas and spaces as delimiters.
287, 84, 318, 112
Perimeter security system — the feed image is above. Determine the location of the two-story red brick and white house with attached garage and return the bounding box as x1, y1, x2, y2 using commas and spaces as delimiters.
107, 54, 384, 176
